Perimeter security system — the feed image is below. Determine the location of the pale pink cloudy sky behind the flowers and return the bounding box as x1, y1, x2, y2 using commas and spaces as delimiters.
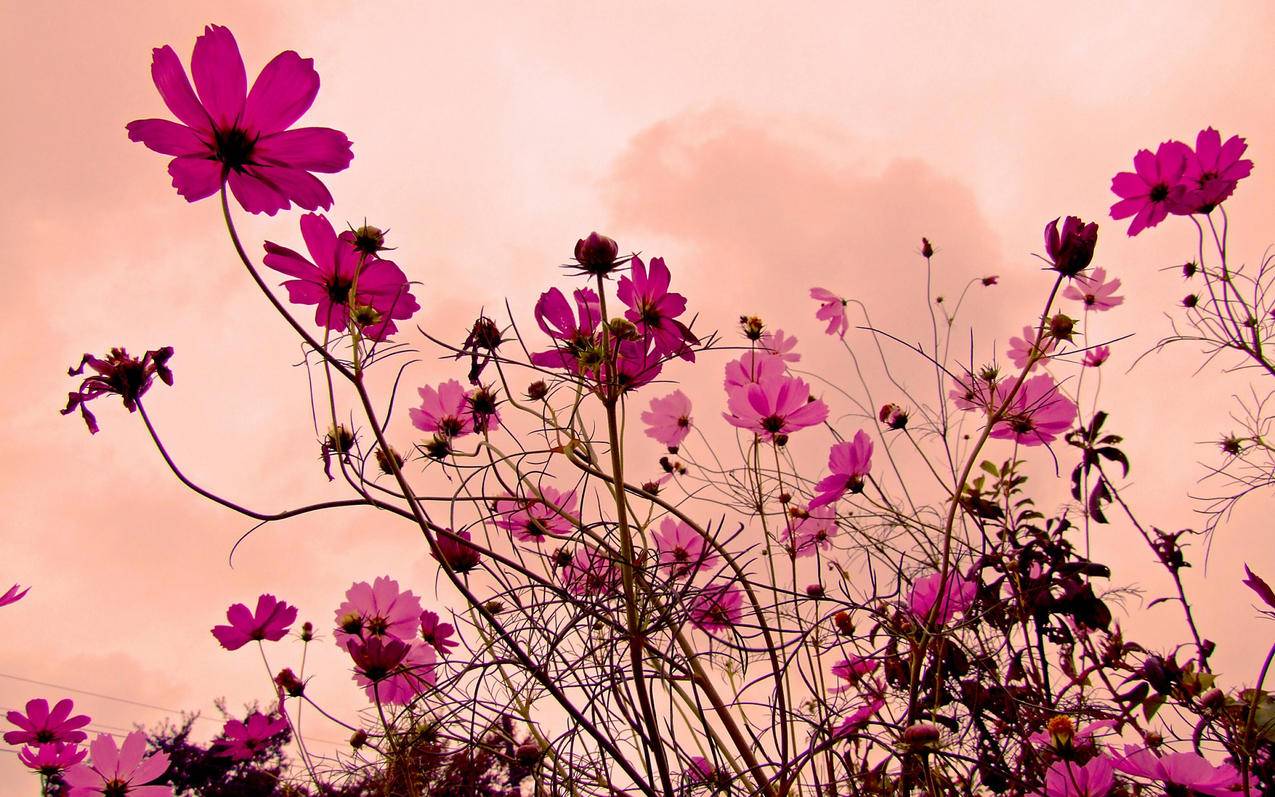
0, 0, 1275, 793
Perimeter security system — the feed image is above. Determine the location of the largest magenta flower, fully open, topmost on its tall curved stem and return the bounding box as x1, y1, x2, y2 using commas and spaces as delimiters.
128, 26, 354, 216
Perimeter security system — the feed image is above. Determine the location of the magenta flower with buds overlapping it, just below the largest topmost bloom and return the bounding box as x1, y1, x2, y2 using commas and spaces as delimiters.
261, 213, 421, 340
